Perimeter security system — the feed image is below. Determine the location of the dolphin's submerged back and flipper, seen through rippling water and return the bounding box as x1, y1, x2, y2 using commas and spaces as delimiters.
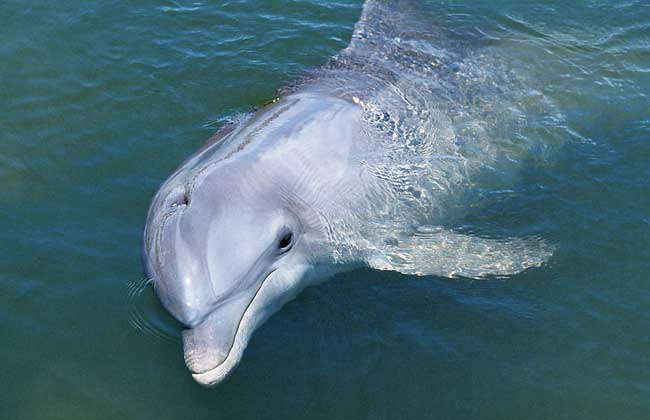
304, 0, 562, 277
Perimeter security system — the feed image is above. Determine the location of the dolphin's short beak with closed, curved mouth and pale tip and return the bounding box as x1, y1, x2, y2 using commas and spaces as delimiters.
182, 270, 275, 387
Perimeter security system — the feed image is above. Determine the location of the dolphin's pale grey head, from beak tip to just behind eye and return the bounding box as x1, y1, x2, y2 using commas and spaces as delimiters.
144, 158, 312, 386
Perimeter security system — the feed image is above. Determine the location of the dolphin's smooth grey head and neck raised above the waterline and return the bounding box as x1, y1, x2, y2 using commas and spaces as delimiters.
143, 93, 360, 385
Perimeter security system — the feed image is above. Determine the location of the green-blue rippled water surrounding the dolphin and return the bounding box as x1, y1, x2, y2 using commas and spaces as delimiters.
0, 0, 650, 419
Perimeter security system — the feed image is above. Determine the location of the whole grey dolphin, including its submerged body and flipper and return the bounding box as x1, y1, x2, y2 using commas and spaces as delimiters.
143, 1, 552, 386
